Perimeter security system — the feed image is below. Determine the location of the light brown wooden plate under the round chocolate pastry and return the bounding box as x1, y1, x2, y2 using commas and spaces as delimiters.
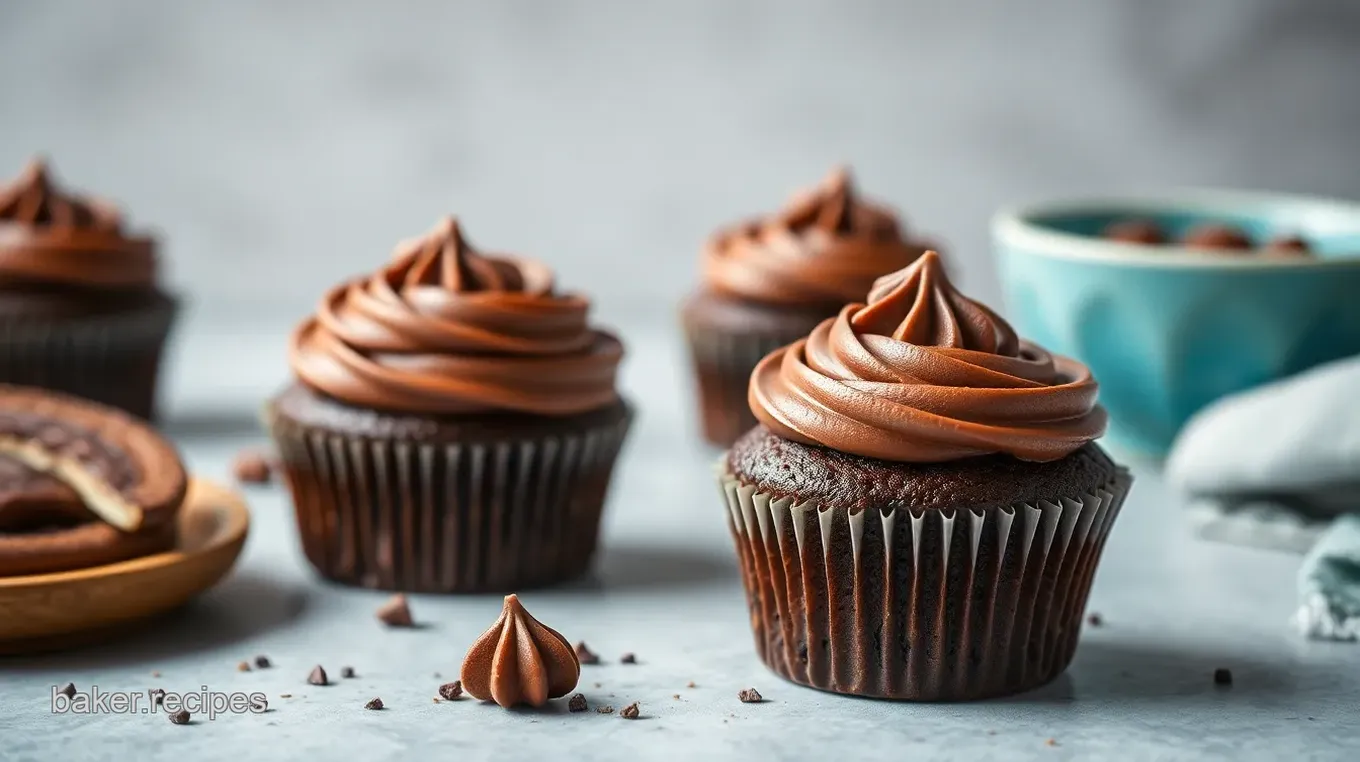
0, 479, 250, 655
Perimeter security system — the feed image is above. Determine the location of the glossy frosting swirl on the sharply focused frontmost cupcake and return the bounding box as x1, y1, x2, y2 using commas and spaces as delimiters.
749, 252, 1106, 463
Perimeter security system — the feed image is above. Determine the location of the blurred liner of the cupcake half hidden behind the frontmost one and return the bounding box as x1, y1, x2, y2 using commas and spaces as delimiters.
687, 328, 808, 446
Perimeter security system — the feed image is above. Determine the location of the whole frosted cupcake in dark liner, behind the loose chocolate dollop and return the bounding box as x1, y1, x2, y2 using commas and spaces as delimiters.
267, 219, 632, 593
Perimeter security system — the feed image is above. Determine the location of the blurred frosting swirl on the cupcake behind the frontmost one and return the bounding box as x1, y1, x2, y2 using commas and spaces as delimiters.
703, 169, 925, 305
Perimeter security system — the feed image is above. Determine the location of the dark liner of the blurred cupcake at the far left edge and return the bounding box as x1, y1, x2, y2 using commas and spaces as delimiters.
0, 301, 178, 419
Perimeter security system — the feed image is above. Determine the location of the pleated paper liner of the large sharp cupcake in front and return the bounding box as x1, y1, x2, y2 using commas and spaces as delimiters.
718, 465, 1132, 701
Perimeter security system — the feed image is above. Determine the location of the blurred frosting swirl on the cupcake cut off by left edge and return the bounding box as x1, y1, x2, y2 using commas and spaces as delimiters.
0, 161, 156, 288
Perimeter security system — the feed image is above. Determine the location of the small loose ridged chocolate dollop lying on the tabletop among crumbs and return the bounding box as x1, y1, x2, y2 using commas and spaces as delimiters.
462, 595, 581, 709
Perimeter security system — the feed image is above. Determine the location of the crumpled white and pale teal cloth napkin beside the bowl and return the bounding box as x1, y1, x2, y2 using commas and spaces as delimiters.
1166, 357, 1360, 641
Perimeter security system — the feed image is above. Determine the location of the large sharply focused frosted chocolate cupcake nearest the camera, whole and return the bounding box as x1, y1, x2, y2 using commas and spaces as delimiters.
719, 252, 1130, 701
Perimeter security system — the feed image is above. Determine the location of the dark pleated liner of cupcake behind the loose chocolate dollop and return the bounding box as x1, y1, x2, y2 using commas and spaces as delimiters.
271, 414, 631, 593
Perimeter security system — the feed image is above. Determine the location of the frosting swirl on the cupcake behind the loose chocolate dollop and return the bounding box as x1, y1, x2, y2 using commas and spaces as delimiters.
290, 218, 623, 415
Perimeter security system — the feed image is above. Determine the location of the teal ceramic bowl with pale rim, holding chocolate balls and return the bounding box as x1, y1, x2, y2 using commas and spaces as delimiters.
991, 192, 1360, 457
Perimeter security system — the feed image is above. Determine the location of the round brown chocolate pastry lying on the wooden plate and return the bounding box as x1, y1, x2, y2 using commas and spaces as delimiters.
0, 385, 188, 577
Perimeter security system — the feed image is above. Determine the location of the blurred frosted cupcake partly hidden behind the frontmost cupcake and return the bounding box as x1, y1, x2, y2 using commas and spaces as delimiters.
681, 169, 928, 446
